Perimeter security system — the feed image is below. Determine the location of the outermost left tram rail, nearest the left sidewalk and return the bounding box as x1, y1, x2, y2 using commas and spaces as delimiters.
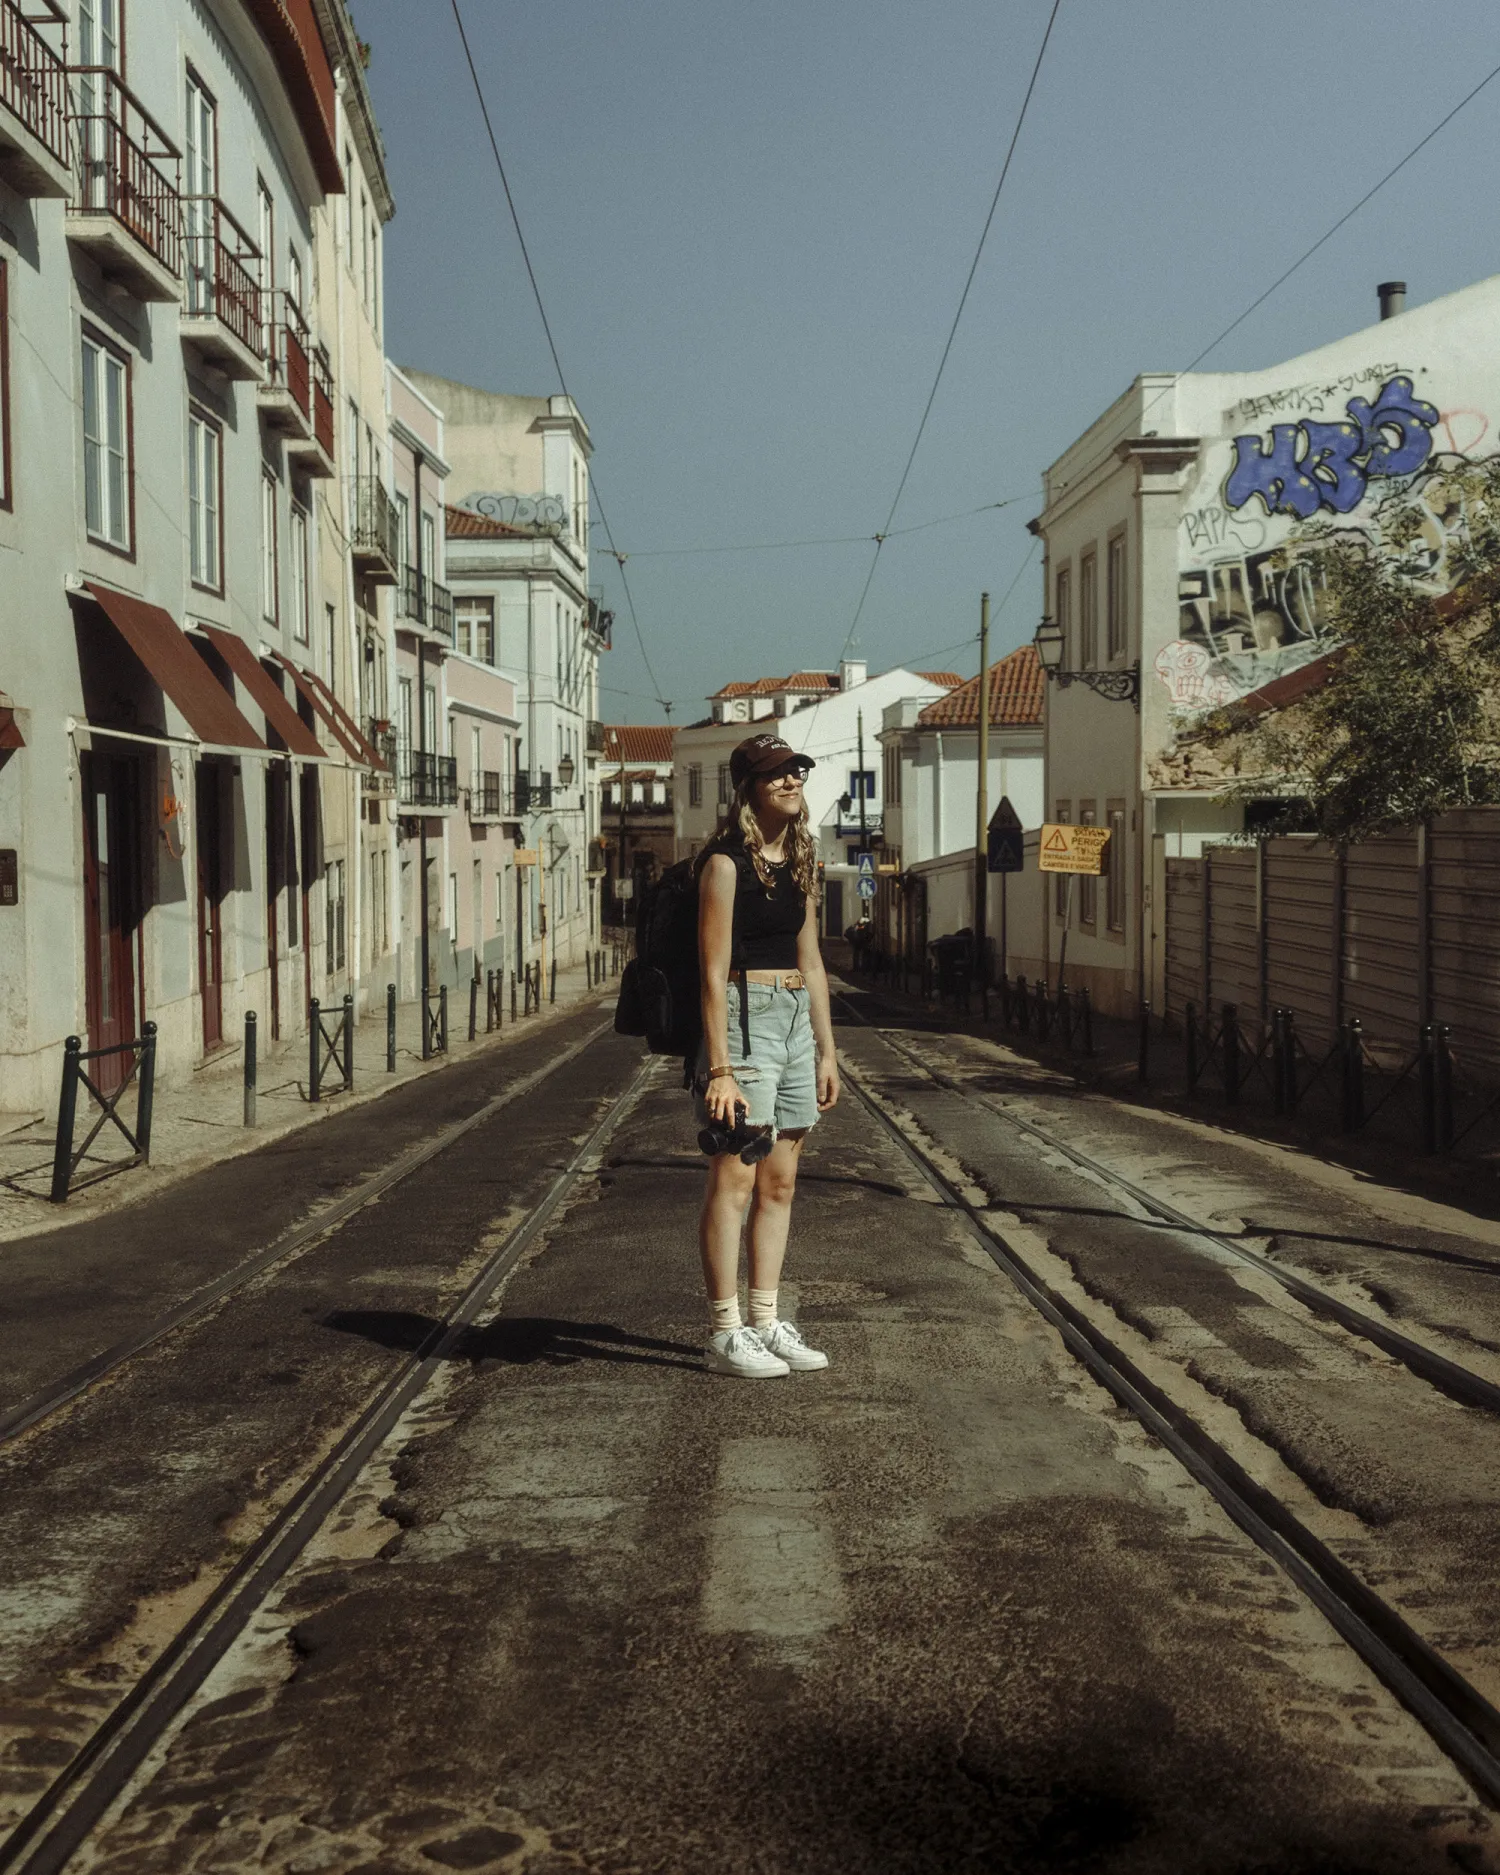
0, 1022, 609, 1448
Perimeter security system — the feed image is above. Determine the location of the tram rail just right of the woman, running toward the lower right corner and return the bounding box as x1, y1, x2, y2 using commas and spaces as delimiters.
840, 1050, 1500, 1804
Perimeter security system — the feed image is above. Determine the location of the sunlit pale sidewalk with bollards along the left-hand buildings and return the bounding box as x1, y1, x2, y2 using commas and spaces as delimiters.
0, 966, 619, 1243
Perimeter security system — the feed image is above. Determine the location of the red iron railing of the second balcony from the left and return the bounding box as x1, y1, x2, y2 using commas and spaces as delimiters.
69, 66, 182, 278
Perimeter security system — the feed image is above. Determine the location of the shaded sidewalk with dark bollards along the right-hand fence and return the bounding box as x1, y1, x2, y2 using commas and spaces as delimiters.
836, 939, 1500, 1217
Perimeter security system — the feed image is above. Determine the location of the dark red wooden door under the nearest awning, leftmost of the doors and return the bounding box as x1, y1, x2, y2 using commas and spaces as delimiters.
81, 752, 141, 1093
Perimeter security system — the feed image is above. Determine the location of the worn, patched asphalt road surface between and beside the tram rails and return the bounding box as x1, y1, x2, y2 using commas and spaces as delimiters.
0, 1007, 1500, 1875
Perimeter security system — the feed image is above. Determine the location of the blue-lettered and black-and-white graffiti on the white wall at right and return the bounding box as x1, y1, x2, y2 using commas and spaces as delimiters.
1155, 366, 1489, 726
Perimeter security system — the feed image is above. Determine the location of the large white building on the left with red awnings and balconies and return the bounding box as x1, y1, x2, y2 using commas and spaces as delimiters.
0, 0, 379, 1110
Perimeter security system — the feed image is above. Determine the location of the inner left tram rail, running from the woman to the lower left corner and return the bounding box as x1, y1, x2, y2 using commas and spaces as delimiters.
0, 1057, 656, 1875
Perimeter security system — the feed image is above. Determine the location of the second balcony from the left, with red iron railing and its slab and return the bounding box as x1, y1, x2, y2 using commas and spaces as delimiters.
68, 66, 182, 302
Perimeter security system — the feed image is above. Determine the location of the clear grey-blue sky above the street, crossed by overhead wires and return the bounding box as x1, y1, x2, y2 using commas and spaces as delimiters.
353, 0, 1500, 722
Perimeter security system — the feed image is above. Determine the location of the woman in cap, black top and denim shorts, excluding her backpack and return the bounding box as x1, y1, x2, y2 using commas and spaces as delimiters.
696, 733, 838, 1380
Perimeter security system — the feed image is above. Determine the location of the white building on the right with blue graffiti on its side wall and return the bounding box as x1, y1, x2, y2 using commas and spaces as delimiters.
1033, 276, 1500, 1014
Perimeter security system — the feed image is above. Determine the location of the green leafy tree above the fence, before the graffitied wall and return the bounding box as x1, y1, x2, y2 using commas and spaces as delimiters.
1204, 459, 1500, 844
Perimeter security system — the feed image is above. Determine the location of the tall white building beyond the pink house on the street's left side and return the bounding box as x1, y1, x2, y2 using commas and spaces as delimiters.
407, 371, 611, 969
